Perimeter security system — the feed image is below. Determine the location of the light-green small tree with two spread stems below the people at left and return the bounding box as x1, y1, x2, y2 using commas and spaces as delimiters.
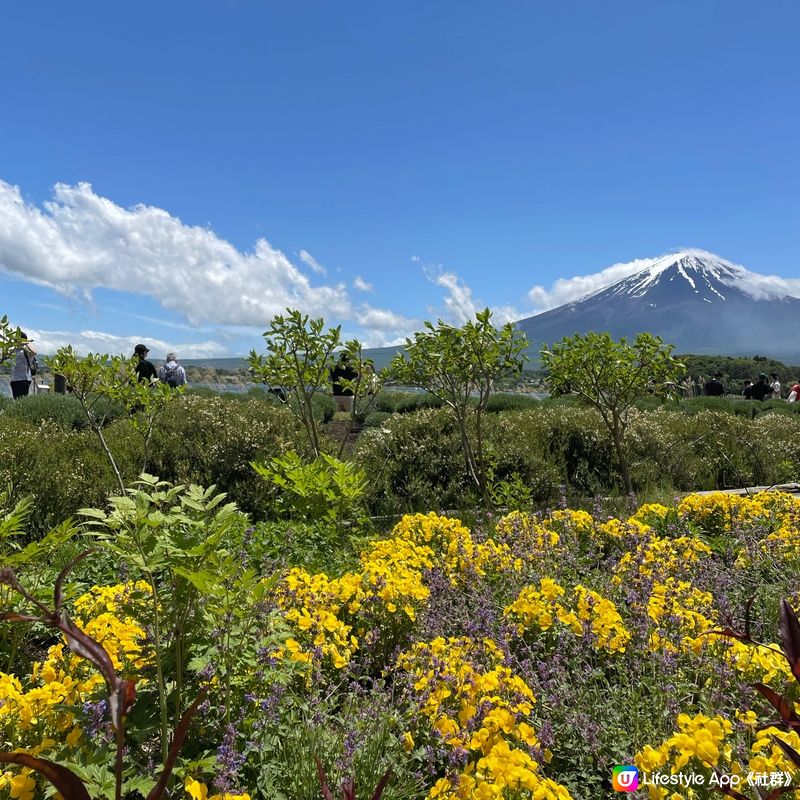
45, 346, 183, 493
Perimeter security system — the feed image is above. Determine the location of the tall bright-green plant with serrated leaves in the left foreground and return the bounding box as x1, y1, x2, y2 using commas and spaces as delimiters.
81, 475, 255, 758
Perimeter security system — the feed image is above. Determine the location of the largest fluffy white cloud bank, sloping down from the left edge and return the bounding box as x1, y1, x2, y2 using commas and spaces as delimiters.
0, 181, 352, 326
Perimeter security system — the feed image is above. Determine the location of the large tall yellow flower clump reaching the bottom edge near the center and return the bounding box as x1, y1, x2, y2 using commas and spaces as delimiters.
398, 637, 570, 800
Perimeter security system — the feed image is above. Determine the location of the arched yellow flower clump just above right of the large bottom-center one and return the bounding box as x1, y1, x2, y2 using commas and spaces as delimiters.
504, 578, 631, 653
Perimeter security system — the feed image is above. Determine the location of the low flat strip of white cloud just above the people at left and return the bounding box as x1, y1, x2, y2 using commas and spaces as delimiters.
26, 328, 229, 361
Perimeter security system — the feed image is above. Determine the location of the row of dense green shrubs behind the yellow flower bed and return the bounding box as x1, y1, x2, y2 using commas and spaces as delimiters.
0, 394, 800, 528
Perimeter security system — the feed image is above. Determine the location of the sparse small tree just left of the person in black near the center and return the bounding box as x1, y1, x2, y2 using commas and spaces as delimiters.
248, 308, 341, 457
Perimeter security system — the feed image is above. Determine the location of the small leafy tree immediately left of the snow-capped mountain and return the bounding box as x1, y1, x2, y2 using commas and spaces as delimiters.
390, 308, 527, 497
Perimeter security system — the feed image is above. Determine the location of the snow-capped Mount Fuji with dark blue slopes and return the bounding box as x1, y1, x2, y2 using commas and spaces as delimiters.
516, 250, 800, 363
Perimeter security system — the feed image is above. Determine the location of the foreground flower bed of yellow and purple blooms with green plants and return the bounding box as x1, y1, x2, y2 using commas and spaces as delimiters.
0, 489, 800, 800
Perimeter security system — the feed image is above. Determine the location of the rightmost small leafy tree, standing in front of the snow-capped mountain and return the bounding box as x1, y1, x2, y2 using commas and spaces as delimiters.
541, 332, 685, 493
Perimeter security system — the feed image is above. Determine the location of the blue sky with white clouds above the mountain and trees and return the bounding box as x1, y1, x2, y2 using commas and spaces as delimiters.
0, 0, 800, 357
